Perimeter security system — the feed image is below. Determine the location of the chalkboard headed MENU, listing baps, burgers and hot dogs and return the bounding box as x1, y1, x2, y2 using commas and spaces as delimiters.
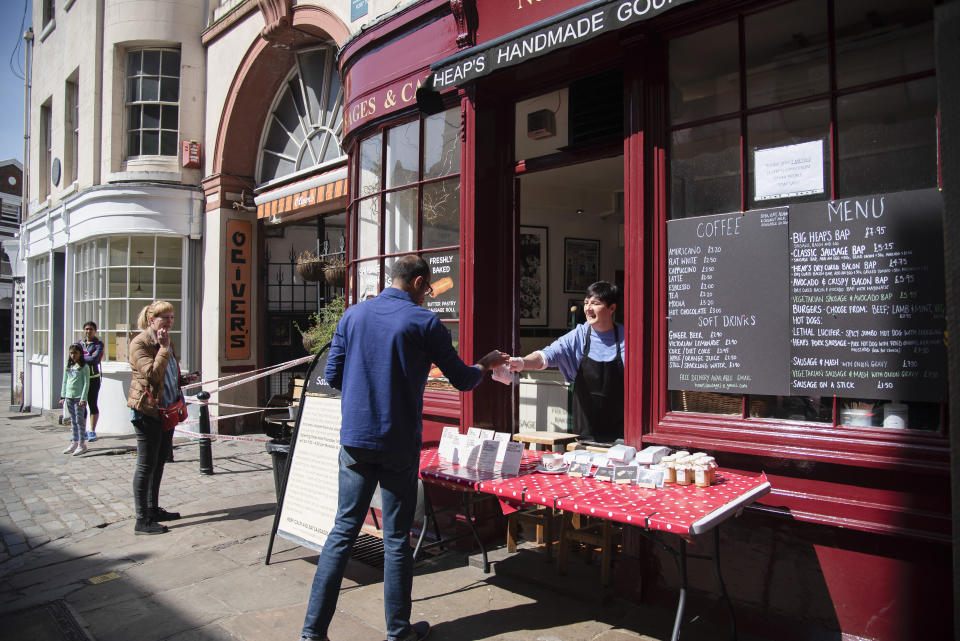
790, 189, 947, 401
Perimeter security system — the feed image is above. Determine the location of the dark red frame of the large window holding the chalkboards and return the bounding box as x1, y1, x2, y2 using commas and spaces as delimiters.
640, 0, 949, 476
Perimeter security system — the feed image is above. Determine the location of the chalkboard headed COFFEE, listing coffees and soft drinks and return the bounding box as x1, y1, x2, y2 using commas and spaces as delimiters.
667, 207, 790, 395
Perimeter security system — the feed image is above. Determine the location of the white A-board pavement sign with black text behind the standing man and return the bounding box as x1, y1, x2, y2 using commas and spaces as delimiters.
276, 353, 340, 550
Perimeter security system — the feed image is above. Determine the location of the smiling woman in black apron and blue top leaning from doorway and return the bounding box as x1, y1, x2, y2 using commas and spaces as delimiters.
510, 280, 625, 443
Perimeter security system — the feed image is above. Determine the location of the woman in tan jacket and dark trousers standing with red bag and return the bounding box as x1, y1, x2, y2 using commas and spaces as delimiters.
127, 300, 193, 534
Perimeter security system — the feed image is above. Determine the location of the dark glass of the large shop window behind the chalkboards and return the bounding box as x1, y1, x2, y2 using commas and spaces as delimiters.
666, 0, 945, 430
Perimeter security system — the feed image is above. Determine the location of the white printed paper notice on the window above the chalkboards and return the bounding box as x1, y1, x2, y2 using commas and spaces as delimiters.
753, 140, 823, 200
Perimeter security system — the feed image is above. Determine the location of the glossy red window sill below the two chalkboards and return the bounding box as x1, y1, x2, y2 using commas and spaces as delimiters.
643, 412, 950, 475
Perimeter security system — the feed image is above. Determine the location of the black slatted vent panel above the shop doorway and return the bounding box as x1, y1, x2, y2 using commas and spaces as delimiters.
569, 69, 623, 147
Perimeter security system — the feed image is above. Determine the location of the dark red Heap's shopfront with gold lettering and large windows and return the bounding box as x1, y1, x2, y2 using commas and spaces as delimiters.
340, 0, 952, 639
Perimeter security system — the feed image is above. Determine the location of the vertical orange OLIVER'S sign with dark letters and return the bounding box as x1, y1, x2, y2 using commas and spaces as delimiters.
226, 220, 253, 360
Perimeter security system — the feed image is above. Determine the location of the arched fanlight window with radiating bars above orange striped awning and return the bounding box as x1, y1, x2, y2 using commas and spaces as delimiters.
257, 47, 345, 185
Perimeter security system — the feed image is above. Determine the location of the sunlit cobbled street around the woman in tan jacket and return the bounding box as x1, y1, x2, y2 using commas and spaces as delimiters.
0, 375, 272, 564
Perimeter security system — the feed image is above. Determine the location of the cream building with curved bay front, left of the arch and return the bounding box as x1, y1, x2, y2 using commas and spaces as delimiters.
21, 0, 208, 433
